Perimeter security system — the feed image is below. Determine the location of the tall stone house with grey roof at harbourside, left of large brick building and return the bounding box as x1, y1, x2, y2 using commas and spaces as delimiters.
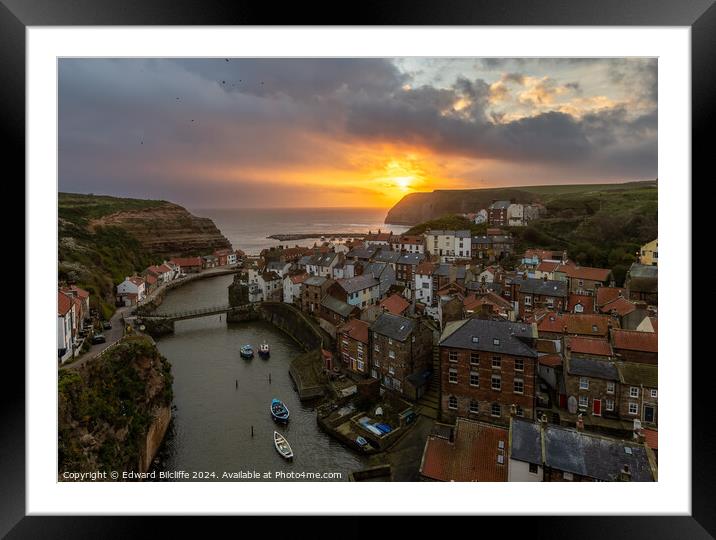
369, 313, 433, 399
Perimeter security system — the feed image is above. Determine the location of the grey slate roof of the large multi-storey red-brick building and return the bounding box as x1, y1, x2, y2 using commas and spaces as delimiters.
440, 319, 537, 358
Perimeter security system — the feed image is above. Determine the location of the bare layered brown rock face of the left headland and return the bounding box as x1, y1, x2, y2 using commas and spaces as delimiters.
89, 203, 231, 258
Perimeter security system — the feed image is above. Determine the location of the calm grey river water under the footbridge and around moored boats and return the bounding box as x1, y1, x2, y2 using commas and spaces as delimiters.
150, 276, 366, 481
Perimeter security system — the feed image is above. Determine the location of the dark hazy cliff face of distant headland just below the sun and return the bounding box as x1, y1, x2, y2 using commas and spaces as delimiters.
385, 188, 537, 225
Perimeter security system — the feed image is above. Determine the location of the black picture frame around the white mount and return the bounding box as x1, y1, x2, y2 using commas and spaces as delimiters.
0, 0, 716, 539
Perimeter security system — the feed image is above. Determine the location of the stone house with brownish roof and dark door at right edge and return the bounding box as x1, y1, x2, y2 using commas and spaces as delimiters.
616, 362, 659, 427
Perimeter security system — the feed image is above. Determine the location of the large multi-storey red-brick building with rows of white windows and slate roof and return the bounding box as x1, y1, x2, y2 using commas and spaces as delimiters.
439, 319, 538, 424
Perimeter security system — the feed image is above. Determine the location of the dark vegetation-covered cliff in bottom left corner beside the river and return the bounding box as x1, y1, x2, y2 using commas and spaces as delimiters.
58, 336, 172, 479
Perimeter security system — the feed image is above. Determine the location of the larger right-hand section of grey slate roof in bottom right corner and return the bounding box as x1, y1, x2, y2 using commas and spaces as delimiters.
544, 424, 654, 482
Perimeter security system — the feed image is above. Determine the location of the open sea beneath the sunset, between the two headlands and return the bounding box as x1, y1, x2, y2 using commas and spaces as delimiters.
190, 208, 410, 255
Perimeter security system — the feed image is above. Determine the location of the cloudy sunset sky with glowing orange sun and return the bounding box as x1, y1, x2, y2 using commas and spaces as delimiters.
58, 57, 657, 208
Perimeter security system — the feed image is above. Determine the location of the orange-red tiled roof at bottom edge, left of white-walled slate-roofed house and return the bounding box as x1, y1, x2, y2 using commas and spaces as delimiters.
420, 418, 509, 482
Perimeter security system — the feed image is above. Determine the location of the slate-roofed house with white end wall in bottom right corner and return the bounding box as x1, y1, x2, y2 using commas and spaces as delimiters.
508, 418, 657, 482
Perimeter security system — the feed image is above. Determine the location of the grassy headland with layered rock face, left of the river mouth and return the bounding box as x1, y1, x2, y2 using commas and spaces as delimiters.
58, 193, 231, 317
